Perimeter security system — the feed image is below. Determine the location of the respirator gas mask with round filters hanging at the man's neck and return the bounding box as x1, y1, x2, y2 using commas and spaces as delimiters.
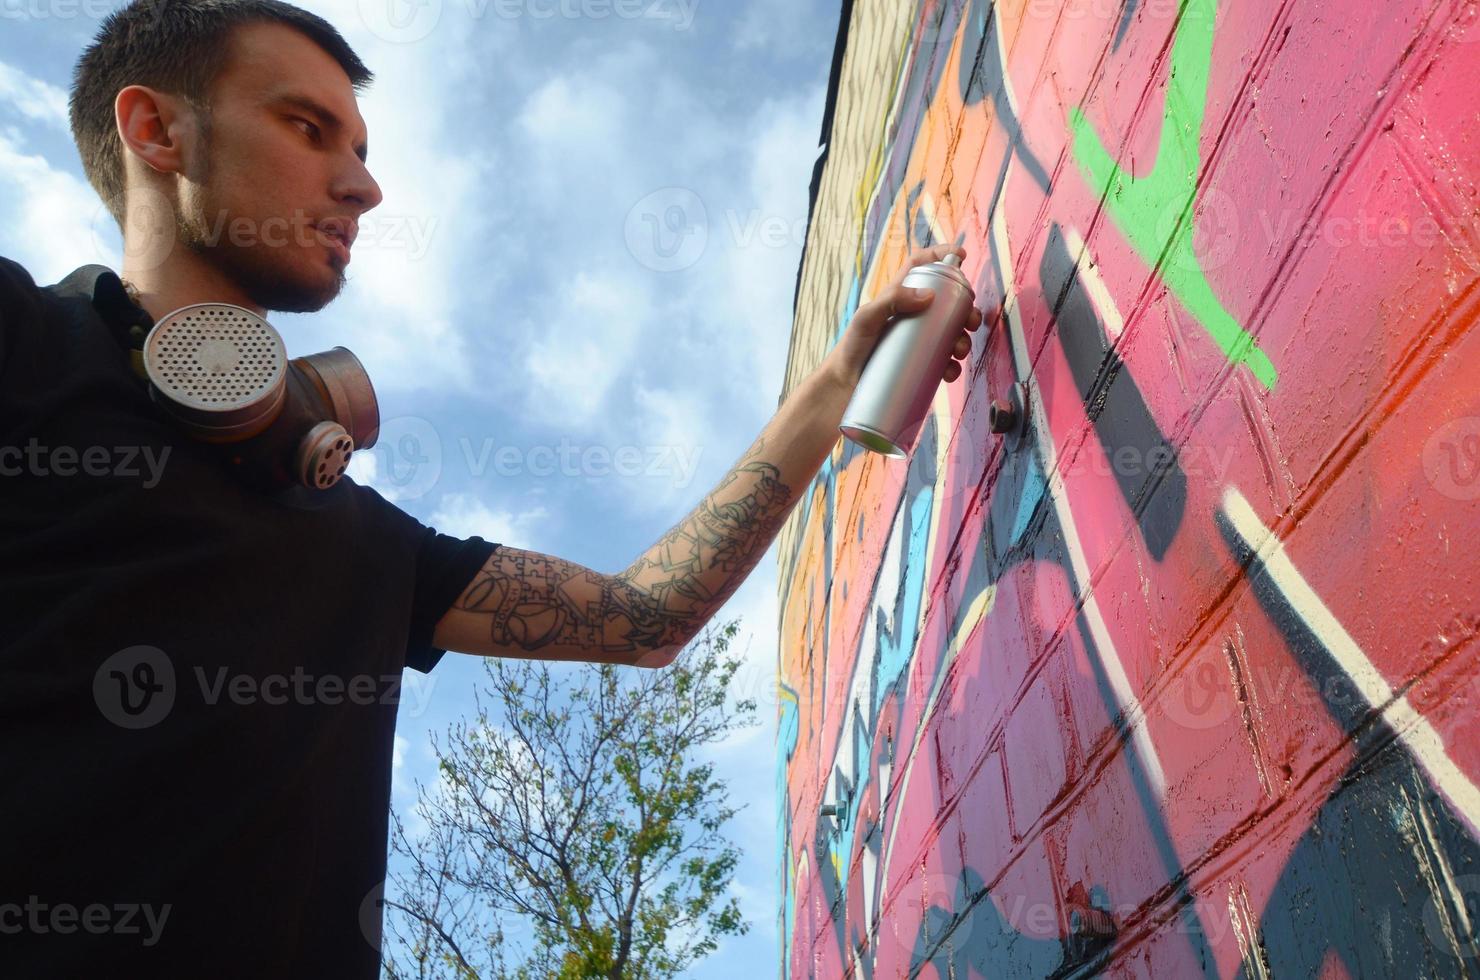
142, 303, 380, 491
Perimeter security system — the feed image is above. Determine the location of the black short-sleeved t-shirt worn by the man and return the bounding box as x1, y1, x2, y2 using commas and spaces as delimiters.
0, 259, 497, 979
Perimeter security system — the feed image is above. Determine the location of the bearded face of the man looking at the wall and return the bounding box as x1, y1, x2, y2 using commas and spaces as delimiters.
179, 24, 380, 312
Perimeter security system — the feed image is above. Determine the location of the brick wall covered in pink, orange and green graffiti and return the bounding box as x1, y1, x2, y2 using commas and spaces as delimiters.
777, 0, 1480, 980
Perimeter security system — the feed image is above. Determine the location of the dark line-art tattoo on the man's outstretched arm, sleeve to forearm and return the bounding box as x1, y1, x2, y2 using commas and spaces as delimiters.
454, 438, 792, 653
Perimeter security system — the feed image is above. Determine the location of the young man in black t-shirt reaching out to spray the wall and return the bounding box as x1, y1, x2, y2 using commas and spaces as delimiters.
0, 0, 980, 977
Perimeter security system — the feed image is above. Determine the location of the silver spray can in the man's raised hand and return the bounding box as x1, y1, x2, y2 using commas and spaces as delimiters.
838, 255, 977, 457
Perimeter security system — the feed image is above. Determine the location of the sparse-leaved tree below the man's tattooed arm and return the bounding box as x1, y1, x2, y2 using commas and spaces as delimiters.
385, 622, 756, 980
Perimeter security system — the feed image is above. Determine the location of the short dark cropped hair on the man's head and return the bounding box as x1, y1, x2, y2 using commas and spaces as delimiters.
70, 0, 374, 225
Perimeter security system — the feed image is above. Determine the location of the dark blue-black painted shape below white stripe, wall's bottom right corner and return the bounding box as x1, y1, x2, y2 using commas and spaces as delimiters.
1215, 514, 1480, 980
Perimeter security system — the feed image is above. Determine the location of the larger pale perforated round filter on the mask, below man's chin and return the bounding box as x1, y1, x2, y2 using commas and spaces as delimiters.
144, 303, 287, 443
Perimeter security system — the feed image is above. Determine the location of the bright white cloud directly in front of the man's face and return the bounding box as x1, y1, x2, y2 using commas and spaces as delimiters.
273, 0, 499, 392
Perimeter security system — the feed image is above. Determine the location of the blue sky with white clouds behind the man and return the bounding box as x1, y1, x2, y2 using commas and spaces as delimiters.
0, 0, 839, 977
